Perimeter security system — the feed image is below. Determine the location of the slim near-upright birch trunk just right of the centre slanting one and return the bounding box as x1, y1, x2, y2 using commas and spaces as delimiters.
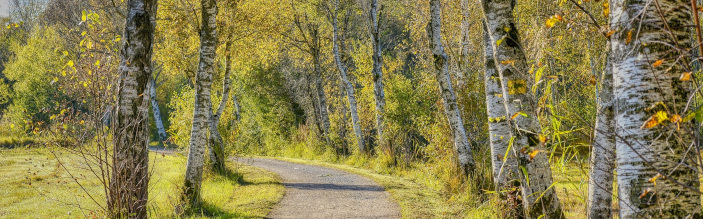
370, 0, 386, 149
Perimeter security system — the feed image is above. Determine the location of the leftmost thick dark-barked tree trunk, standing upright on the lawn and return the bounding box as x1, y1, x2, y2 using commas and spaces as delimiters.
107, 0, 157, 218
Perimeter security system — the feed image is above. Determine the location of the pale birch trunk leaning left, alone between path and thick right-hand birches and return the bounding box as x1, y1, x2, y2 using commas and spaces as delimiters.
427, 0, 475, 175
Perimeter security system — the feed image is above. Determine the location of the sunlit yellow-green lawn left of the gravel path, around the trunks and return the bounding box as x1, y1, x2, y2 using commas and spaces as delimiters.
0, 148, 284, 218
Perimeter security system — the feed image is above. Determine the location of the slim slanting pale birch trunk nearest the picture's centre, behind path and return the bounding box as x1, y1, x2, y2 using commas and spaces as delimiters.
332, 0, 366, 153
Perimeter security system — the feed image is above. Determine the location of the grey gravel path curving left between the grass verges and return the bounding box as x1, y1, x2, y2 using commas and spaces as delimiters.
245, 158, 400, 219
